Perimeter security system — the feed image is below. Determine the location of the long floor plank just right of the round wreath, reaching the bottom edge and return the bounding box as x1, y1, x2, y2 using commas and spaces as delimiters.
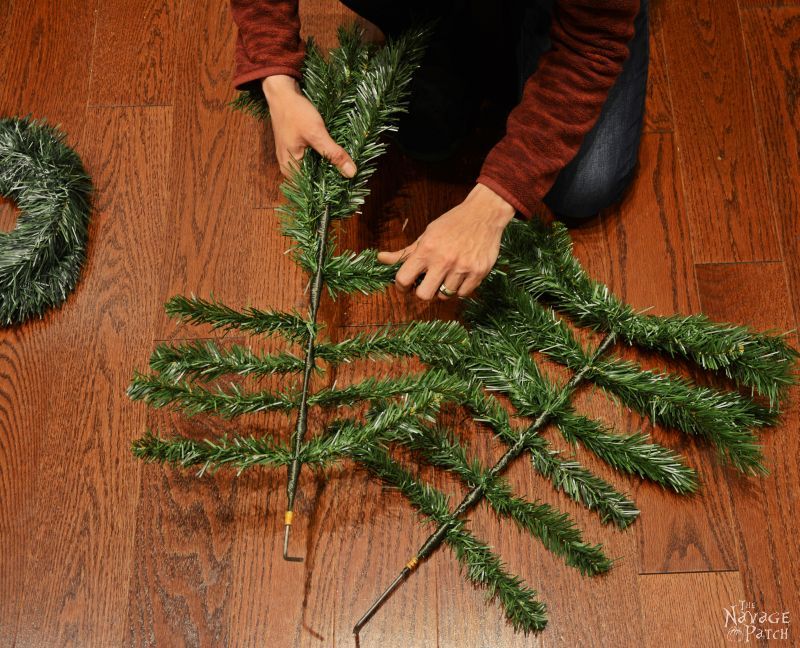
9, 108, 172, 645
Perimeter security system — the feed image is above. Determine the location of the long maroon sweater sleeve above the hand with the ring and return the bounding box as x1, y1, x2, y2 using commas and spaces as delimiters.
478, 0, 639, 218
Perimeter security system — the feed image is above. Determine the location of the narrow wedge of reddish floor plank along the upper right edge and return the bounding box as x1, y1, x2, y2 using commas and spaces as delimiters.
742, 8, 800, 324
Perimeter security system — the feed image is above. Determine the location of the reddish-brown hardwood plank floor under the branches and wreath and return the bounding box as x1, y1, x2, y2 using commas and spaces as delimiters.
0, 0, 800, 648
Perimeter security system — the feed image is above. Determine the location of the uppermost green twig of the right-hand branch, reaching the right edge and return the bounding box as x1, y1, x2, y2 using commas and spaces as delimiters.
500, 223, 798, 407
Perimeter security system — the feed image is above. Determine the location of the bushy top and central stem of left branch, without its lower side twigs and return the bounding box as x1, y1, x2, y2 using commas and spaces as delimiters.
266, 27, 422, 560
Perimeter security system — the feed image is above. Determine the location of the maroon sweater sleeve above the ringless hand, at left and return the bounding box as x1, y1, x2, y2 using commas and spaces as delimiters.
231, 0, 305, 89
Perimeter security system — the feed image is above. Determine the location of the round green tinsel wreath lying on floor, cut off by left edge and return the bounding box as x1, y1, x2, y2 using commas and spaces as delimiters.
0, 117, 92, 326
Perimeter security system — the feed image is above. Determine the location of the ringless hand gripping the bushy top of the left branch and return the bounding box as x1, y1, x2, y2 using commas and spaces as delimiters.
261, 74, 356, 178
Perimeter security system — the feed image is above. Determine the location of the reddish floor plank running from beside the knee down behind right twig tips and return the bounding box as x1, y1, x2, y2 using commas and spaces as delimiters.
594, 130, 736, 573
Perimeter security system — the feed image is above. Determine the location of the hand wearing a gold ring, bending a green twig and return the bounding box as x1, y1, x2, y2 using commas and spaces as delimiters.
378, 184, 515, 301
